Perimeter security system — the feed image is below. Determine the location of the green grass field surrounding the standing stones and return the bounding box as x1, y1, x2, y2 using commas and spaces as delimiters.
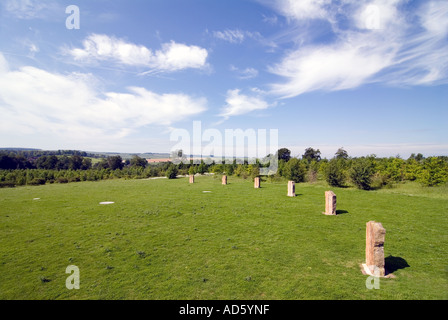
0, 176, 448, 300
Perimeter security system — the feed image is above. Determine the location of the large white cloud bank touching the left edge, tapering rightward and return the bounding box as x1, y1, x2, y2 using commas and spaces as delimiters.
0, 54, 207, 144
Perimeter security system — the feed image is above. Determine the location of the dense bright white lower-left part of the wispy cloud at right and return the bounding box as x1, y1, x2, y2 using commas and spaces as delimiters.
269, 32, 394, 97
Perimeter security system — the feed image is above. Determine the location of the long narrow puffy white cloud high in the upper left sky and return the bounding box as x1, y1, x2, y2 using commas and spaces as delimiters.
64, 34, 208, 72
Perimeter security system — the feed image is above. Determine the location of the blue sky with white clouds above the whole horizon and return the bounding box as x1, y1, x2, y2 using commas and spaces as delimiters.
0, 0, 448, 158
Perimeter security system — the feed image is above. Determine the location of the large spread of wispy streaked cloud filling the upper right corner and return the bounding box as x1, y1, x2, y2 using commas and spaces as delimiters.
269, 0, 448, 98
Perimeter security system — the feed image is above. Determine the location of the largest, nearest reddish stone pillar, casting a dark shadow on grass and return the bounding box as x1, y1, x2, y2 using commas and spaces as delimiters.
364, 221, 386, 277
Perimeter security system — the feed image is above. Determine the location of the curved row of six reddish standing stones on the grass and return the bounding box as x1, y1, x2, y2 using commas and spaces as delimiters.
189, 175, 386, 277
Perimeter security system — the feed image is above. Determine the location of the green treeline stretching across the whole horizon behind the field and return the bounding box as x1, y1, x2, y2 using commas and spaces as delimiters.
0, 147, 448, 190
